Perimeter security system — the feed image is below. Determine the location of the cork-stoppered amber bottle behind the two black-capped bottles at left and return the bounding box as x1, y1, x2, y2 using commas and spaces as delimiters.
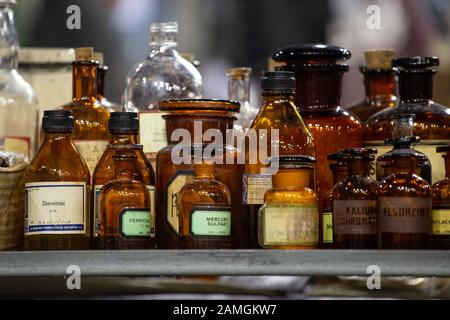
61, 48, 109, 174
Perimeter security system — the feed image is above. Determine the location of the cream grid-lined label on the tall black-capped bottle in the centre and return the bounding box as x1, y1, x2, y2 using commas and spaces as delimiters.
242, 174, 272, 204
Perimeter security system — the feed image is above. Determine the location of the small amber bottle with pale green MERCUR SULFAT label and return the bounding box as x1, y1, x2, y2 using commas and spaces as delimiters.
178, 148, 233, 249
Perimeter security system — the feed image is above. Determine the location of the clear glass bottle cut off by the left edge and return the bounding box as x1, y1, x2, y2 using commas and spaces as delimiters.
0, 0, 39, 159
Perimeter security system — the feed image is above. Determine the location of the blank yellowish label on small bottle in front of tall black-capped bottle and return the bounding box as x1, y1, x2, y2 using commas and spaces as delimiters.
261, 205, 319, 246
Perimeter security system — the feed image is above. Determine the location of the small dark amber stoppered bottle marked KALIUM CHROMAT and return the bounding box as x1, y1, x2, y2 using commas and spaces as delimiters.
332, 148, 378, 249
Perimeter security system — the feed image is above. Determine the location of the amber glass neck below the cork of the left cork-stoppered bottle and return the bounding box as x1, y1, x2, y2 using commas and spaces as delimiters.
72, 61, 97, 101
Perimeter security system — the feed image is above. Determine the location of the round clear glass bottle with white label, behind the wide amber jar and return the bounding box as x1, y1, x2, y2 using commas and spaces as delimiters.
123, 22, 203, 165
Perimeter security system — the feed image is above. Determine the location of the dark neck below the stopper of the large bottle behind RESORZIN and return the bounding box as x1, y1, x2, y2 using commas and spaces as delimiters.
398, 71, 434, 102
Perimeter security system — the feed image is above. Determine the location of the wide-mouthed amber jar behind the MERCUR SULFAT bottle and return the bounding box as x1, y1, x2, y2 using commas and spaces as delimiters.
156, 99, 241, 249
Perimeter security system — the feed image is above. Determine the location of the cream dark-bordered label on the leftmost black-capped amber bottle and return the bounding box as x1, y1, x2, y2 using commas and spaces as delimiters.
25, 182, 87, 235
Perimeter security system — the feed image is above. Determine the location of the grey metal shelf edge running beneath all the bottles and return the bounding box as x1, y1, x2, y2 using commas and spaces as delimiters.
0, 250, 450, 277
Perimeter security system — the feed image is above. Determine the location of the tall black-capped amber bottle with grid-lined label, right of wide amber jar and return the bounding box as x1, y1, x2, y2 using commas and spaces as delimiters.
242, 71, 316, 248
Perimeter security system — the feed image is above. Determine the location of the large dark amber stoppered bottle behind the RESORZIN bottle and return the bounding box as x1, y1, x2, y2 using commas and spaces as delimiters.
365, 57, 450, 182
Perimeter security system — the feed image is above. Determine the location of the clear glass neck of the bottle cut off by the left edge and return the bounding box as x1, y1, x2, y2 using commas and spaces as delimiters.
0, 5, 19, 70
